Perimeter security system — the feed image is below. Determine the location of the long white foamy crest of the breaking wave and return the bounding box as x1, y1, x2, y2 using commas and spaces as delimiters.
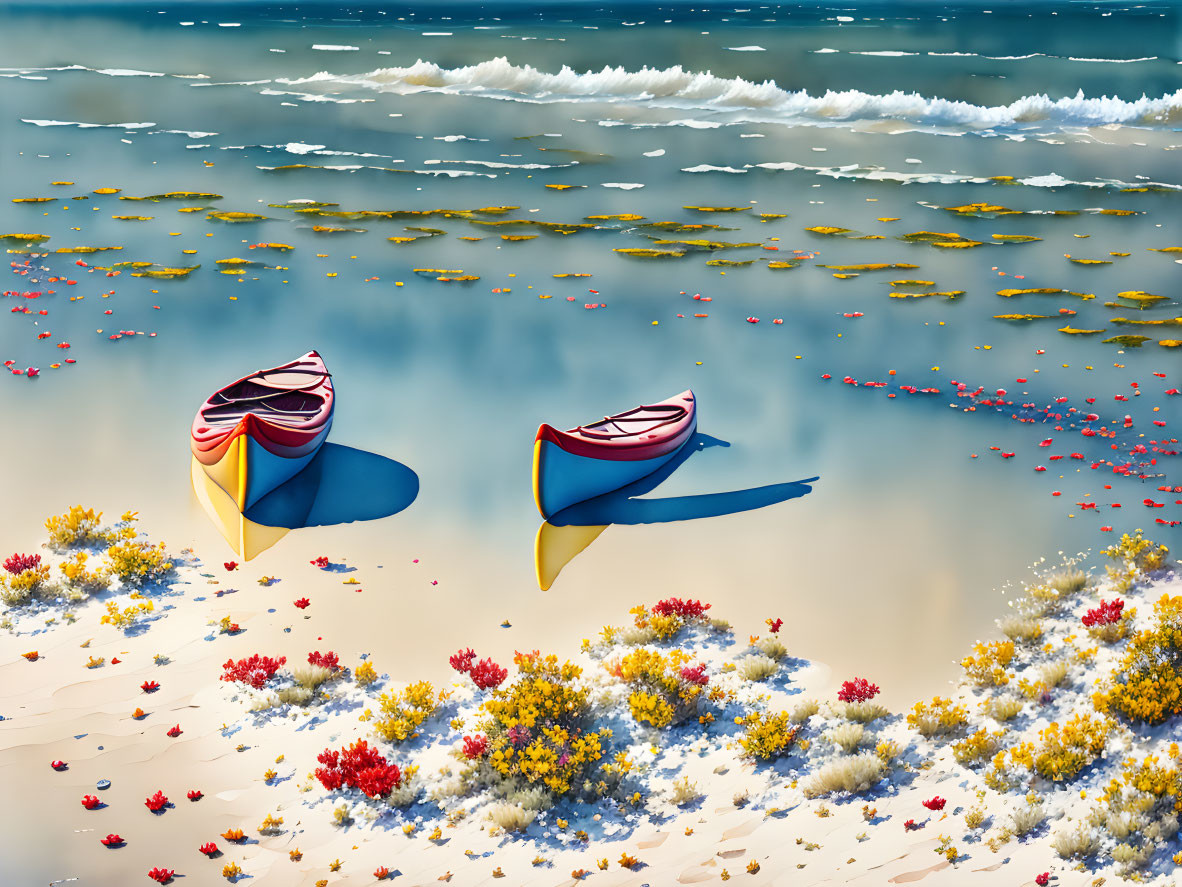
279, 57, 1182, 132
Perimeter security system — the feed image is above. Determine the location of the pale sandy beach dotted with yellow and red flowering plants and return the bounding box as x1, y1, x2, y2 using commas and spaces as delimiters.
0, 506, 1182, 885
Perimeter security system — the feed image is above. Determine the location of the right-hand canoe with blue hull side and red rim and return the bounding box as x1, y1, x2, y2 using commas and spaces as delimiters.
533, 390, 697, 518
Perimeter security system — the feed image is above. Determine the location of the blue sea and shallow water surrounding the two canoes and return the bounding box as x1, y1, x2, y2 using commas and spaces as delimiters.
0, 5, 1182, 703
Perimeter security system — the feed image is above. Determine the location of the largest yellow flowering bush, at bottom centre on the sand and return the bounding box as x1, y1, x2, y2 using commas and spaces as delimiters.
481, 650, 609, 795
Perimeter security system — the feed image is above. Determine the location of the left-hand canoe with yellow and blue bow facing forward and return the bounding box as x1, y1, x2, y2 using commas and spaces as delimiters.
191, 351, 336, 511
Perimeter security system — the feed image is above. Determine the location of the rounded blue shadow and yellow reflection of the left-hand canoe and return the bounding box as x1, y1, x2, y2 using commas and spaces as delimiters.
191, 444, 418, 561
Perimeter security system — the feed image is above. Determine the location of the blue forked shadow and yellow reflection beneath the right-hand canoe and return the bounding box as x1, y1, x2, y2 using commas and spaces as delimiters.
533, 432, 820, 591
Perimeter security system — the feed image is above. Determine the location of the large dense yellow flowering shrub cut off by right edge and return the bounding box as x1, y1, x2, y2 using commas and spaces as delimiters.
1092, 595, 1182, 724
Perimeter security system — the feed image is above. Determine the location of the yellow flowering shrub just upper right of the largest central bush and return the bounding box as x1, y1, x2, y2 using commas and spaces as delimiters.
608, 647, 708, 727
